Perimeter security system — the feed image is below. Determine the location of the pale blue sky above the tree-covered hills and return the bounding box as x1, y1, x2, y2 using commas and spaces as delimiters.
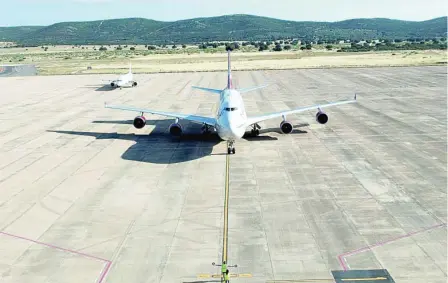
0, 0, 448, 26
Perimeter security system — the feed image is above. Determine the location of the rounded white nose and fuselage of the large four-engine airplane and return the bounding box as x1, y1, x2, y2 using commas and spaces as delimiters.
215, 89, 247, 141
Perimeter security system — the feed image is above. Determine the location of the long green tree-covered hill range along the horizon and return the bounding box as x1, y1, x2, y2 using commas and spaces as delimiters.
0, 15, 447, 45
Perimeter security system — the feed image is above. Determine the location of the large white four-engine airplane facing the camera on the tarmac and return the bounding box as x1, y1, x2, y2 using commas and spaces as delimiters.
105, 51, 356, 154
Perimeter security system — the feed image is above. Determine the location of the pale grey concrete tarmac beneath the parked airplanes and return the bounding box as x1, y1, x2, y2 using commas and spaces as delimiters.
0, 67, 447, 283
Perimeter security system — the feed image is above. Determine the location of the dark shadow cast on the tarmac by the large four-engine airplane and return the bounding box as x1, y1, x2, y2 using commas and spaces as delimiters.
47, 119, 306, 164
